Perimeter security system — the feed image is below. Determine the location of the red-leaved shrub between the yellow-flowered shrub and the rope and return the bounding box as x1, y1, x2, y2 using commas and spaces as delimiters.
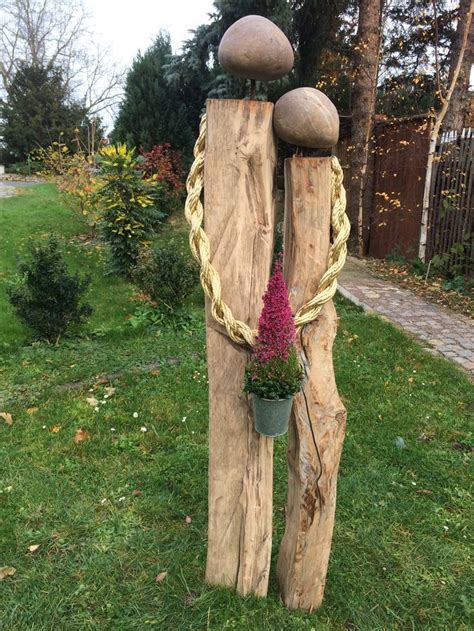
138, 143, 184, 215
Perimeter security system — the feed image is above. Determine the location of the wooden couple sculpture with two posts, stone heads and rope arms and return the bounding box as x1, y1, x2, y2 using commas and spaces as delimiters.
185, 16, 349, 610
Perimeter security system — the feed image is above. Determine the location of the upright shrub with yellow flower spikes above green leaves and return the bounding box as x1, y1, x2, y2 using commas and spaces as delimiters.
95, 144, 165, 274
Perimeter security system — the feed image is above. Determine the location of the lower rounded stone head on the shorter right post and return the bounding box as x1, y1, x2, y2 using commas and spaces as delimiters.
273, 88, 339, 149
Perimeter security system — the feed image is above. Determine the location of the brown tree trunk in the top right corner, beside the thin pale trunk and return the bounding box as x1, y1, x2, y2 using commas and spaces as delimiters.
443, 0, 474, 131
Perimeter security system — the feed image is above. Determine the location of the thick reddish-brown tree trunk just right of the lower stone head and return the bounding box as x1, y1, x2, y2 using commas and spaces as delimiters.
348, 0, 383, 254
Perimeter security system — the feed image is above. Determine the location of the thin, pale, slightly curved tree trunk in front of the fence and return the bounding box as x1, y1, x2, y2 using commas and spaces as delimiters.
418, 0, 474, 261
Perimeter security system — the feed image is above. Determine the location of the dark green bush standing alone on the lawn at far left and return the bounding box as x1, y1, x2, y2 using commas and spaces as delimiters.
7, 236, 92, 342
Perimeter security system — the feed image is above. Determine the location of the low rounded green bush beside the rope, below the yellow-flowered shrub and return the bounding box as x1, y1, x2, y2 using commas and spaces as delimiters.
132, 246, 199, 312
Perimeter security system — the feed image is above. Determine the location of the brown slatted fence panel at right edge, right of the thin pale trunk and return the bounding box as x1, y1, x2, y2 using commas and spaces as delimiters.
427, 128, 474, 273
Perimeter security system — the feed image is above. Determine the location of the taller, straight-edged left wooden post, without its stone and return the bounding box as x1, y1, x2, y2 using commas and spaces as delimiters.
204, 100, 276, 596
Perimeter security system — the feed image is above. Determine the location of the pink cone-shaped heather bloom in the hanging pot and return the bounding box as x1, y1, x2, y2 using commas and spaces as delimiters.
254, 256, 296, 363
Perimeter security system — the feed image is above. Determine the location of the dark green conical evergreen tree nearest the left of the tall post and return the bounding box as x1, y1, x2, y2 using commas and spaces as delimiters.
112, 32, 194, 151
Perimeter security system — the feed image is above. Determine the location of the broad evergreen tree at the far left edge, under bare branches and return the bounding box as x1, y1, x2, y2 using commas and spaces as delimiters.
1, 64, 85, 161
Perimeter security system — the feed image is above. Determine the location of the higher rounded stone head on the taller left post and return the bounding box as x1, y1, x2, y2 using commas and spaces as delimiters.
218, 15, 295, 81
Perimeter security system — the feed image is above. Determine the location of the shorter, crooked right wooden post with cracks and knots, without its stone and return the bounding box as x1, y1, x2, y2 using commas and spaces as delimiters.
277, 157, 346, 611
